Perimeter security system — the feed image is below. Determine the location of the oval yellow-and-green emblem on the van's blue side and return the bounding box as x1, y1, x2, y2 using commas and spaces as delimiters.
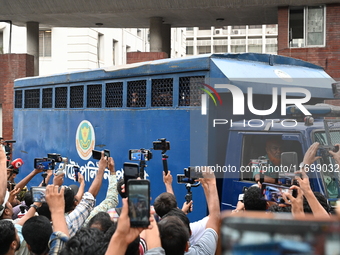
76, 120, 96, 160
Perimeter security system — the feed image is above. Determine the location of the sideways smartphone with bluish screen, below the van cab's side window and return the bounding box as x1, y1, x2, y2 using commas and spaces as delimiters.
261, 182, 297, 204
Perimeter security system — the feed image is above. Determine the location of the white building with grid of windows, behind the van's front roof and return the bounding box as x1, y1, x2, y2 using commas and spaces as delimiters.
186, 25, 277, 56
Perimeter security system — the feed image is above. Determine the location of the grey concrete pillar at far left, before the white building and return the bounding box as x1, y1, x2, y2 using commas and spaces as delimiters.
26, 21, 39, 76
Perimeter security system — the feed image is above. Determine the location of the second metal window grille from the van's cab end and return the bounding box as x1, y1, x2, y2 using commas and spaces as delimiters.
151, 78, 173, 106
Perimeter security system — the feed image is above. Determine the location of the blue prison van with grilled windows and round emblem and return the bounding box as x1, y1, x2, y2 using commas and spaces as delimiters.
13, 53, 340, 220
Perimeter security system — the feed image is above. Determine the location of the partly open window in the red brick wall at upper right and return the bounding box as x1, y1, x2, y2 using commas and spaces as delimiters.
289, 6, 325, 47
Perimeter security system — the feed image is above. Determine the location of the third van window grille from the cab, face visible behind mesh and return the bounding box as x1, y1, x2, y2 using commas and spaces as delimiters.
127, 80, 146, 107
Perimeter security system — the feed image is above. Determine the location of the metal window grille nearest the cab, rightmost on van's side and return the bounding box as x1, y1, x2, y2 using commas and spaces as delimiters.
178, 76, 204, 106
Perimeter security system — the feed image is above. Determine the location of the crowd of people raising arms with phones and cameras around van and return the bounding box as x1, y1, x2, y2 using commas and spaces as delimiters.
0, 141, 340, 255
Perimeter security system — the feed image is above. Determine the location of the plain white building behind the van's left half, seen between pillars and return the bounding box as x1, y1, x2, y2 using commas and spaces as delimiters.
0, 22, 186, 75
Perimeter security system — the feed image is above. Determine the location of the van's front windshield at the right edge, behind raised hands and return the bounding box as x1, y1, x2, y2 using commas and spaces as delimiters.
314, 130, 340, 198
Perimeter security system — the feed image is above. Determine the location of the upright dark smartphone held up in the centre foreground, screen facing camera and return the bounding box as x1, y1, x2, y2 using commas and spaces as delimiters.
127, 180, 150, 228
